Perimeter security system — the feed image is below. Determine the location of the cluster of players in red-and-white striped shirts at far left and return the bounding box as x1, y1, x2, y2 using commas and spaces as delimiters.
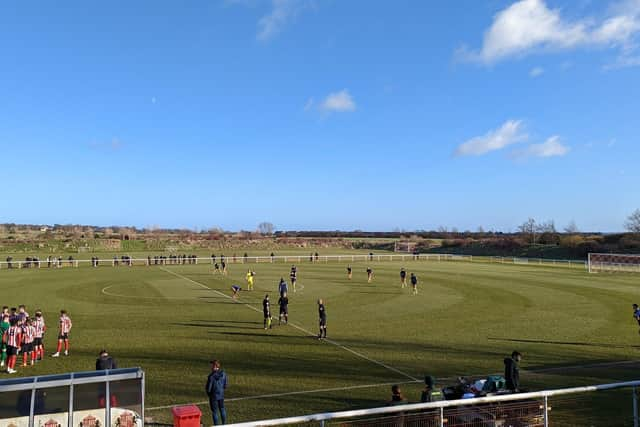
0, 305, 73, 374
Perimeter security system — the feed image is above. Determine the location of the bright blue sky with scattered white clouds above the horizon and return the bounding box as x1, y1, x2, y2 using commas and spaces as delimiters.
0, 0, 640, 231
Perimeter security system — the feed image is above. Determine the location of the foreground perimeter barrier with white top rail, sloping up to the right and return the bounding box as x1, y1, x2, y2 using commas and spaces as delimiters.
221, 381, 640, 427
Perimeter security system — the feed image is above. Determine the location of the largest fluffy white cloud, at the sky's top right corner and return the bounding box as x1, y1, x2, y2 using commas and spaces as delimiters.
462, 0, 640, 64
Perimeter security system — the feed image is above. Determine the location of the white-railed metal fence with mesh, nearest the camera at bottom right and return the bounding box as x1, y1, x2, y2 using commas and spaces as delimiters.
224, 381, 640, 427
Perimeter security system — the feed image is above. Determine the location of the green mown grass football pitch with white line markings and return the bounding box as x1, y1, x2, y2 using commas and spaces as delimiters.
0, 256, 640, 425
